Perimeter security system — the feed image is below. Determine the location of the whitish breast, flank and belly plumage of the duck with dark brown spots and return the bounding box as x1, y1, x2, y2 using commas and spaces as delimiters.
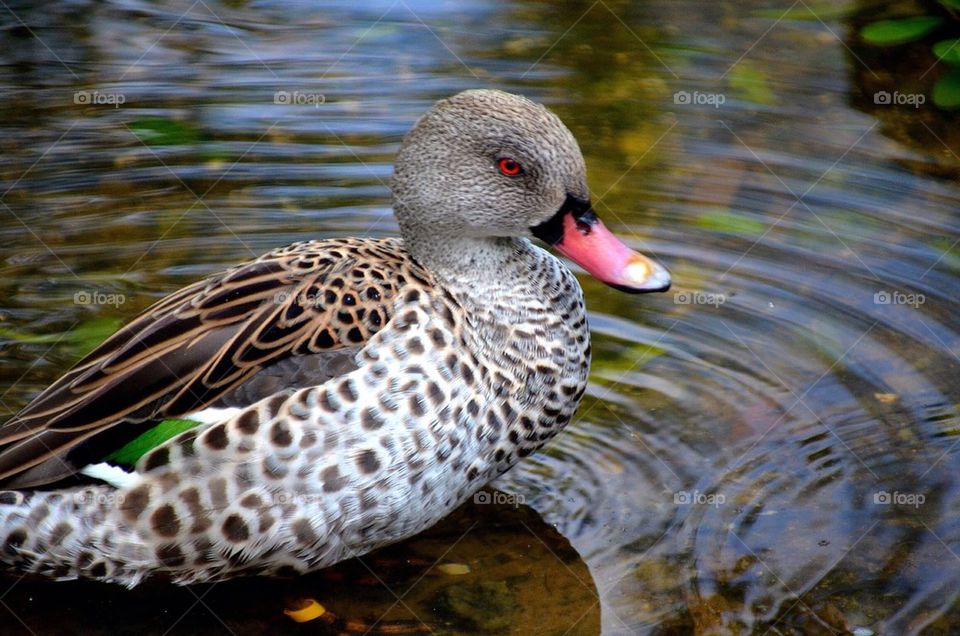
0, 241, 589, 585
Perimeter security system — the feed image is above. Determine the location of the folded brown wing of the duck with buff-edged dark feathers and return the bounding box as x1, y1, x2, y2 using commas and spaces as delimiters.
0, 239, 427, 487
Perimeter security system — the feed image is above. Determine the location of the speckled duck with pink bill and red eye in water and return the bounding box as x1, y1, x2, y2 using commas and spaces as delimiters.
0, 89, 670, 587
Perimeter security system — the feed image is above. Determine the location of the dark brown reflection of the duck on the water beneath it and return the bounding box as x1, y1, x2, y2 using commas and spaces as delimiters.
0, 502, 600, 636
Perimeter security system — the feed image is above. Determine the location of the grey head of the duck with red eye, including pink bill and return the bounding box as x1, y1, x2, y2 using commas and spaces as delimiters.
391, 90, 670, 293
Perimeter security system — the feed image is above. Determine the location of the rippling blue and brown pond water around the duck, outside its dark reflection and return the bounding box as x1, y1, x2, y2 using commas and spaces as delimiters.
0, 0, 960, 634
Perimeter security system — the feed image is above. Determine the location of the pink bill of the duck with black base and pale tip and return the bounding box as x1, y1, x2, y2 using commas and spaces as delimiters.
532, 196, 670, 294
